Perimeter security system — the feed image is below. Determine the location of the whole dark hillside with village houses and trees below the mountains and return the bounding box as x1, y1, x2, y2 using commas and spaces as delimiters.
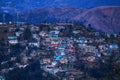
0, 22, 120, 80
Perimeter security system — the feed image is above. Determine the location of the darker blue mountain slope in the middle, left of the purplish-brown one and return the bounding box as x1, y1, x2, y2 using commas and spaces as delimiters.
20, 6, 87, 23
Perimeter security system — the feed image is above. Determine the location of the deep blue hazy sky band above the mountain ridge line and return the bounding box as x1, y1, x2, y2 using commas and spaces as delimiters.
0, 0, 120, 12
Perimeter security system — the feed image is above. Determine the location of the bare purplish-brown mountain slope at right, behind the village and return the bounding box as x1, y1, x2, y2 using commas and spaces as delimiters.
74, 6, 120, 32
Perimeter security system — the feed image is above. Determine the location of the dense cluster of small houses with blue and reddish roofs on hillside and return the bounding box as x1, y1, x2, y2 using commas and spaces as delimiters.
1, 24, 120, 80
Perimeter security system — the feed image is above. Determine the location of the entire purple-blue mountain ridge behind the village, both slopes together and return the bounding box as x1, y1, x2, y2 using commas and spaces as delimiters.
20, 6, 120, 33
